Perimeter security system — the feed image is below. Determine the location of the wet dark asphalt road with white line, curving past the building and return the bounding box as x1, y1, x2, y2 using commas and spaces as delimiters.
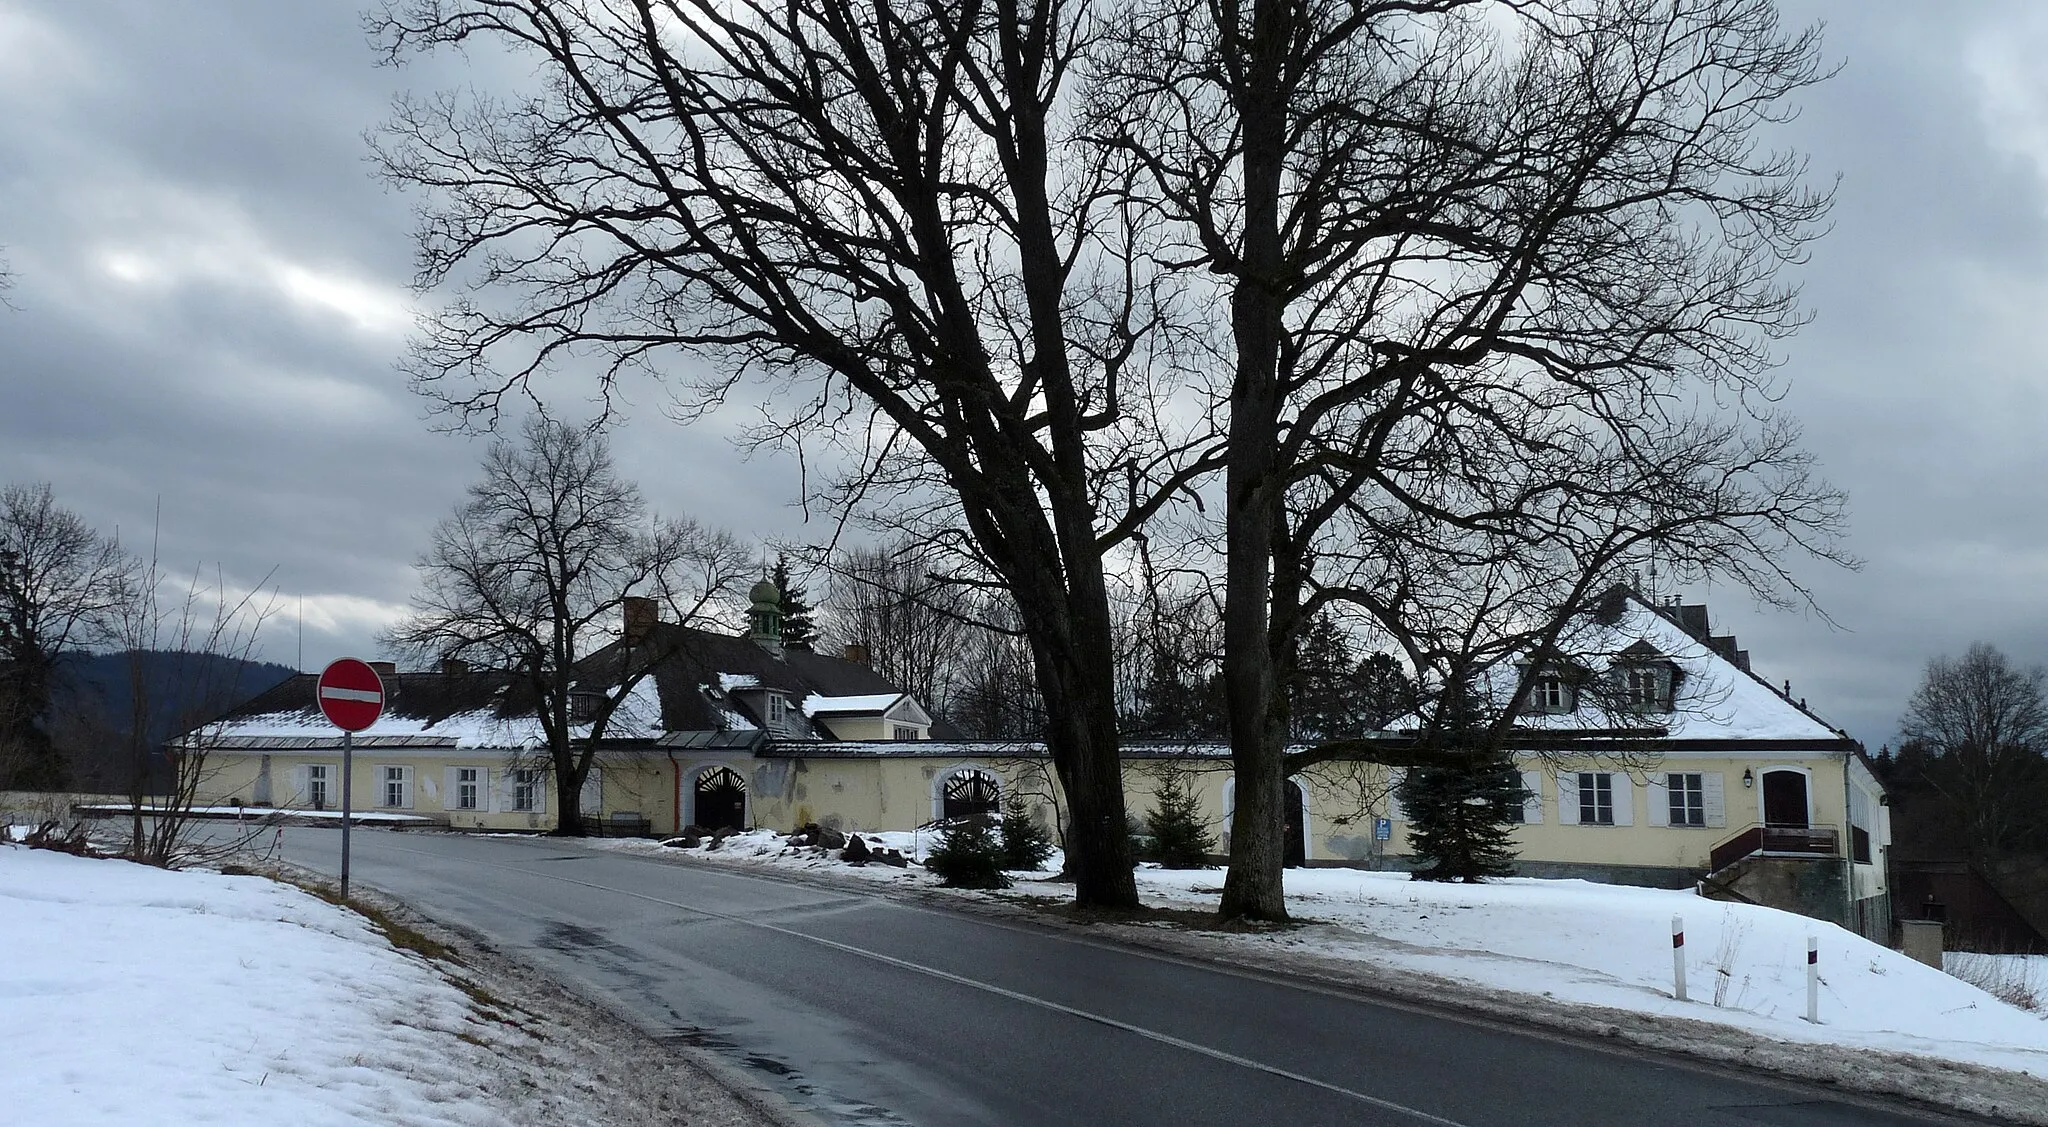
285, 828, 1974, 1127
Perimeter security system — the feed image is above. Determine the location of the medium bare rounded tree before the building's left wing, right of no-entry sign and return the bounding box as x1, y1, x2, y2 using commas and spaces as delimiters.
383, 416, 754, 836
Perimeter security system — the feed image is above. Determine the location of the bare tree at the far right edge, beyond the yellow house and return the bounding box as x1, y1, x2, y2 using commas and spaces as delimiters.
1898, 641, 2048, 852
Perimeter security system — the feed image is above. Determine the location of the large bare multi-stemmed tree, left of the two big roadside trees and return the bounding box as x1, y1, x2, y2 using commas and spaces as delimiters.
375, 0, 1208, 906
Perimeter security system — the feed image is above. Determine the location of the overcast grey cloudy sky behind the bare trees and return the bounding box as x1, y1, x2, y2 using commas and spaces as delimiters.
0, 0, 2048, 750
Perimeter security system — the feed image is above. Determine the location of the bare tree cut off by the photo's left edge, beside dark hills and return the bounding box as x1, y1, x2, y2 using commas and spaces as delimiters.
0, 484, 135, 789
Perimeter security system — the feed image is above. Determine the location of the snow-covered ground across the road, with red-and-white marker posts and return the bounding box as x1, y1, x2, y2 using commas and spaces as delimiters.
592, 830, 2048, 1078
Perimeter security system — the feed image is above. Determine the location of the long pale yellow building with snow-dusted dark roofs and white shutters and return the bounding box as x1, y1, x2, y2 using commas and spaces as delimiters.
184, 590, 1890, 938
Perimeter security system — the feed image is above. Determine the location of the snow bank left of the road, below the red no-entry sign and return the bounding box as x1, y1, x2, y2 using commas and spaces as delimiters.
0, 844, 506, 1127
